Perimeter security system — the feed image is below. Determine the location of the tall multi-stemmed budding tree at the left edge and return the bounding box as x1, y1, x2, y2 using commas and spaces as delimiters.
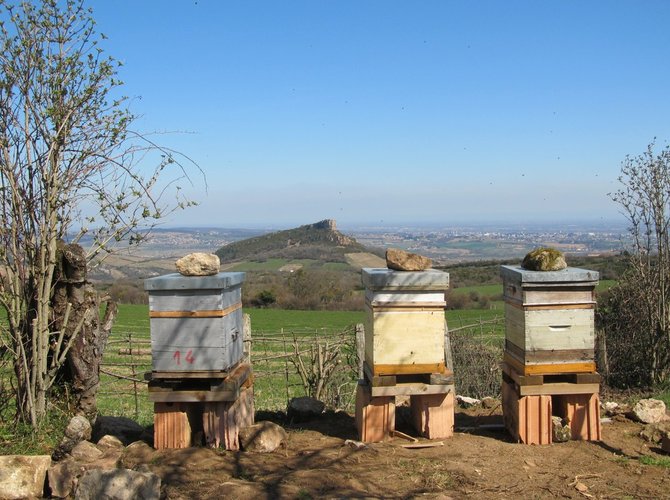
0, 0, 200, 425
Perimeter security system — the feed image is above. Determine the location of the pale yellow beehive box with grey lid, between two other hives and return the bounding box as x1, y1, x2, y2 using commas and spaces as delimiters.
362, 268, 449, 376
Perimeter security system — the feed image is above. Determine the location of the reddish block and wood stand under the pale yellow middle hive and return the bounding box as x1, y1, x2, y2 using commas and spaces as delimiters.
356, 364, 455, 443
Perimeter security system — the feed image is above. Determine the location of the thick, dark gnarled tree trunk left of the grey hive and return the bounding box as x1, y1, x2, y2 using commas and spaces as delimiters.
52, 244, 117, 421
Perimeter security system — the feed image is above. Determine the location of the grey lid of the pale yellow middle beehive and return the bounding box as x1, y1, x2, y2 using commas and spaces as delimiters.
361, 267, 449, 290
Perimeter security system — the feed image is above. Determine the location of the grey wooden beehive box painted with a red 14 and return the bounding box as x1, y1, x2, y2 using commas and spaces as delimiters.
144, 273, 244, 372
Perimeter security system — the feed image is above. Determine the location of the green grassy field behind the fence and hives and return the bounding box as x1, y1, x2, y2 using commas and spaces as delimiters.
99, 304, 504, 425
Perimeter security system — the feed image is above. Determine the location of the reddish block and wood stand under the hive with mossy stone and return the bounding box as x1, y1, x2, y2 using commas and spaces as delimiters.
501, 363, 601, 444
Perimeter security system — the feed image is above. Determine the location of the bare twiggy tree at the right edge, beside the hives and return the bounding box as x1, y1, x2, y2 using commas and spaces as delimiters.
603, 143, 670, 384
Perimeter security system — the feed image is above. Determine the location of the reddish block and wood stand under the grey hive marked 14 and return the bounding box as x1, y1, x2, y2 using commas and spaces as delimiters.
145, 363, 254, 450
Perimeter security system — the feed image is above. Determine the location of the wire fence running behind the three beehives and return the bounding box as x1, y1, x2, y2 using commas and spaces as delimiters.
98, 316, 504, 423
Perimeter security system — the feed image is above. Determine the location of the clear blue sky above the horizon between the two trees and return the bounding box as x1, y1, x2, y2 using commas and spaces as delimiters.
88, 0, 670, 227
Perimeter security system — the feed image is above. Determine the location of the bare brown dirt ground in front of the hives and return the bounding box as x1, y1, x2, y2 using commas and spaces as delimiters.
118, 408, 670, 499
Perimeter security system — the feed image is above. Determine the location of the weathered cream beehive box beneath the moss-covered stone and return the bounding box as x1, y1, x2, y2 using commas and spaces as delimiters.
500, 266, 598, 375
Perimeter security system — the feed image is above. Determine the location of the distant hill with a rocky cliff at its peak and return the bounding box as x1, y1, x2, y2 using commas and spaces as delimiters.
215, 219, 370, 264
